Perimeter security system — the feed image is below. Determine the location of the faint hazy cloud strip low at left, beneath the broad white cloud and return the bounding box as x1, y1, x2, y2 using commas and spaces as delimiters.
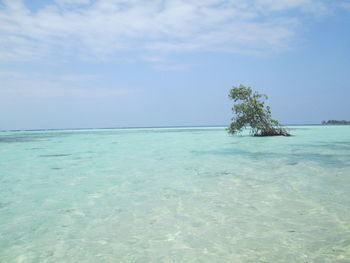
0, 70, 136, 98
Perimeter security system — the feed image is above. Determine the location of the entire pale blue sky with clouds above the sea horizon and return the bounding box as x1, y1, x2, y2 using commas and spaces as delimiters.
0, 0, 350, 130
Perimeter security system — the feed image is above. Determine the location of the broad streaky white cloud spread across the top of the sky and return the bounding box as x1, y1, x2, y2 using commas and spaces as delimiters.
0, 0, 334, 61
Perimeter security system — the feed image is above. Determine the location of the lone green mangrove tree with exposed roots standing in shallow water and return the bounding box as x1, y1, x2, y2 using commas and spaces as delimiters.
228, 85, 290, 136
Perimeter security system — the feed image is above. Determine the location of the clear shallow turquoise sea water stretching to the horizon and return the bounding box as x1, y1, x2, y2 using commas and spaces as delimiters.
0, 126, 350, 263
